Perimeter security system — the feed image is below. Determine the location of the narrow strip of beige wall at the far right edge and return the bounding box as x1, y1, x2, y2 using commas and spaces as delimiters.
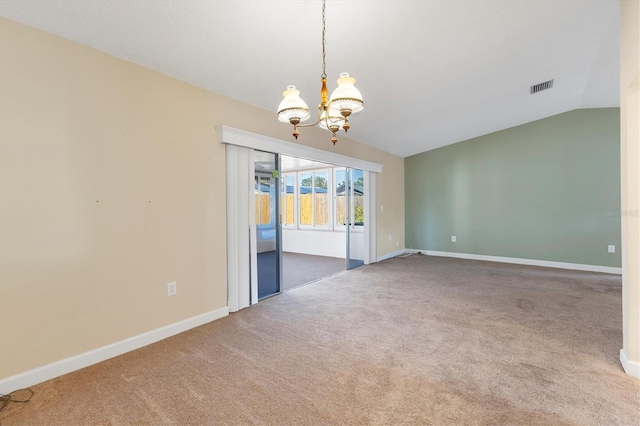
620, 1, 640, 368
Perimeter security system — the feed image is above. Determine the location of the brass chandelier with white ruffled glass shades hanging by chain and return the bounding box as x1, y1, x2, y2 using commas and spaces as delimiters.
278, 0, 364, 145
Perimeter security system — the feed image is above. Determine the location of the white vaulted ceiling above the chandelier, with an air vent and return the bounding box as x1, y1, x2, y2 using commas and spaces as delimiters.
0, 0, 620, 156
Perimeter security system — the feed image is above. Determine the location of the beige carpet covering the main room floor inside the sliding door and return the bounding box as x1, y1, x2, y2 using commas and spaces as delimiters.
0, 256, 640, 426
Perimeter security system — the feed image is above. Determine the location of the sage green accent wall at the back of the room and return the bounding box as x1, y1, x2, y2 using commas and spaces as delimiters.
405, 108, 621, 267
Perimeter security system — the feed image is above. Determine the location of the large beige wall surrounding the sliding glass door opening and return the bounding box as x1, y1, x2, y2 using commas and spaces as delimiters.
0, 19, 404, 378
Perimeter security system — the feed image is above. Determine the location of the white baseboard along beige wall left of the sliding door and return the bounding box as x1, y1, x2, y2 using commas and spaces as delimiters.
0, 306, 229, 395
